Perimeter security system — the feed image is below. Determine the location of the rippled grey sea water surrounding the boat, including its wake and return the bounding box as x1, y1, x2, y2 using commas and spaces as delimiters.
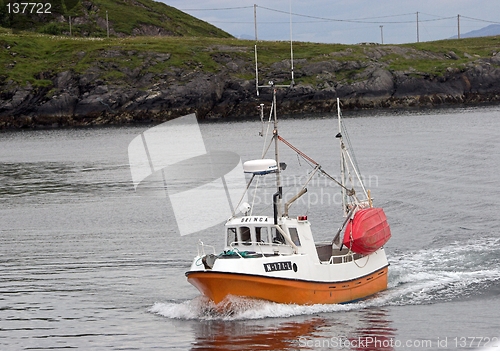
0, 107, 500, 350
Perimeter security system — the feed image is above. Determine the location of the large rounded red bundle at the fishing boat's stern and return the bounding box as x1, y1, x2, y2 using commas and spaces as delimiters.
343, 208, 391, 255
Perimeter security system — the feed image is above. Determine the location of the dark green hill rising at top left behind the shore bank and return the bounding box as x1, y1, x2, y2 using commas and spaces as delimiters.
0, 0, 231, 38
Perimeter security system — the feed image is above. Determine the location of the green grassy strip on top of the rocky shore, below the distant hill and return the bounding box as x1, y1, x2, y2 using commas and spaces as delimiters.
0, 26, 500, 86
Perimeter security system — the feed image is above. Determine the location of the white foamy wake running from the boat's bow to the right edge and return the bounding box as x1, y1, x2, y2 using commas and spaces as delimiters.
150, 238, 500, 320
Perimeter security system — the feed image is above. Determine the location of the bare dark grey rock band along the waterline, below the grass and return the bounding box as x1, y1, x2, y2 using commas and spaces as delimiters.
0, 46, 500, 129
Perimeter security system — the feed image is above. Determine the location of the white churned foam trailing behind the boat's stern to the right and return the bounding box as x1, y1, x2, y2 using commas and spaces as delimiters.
387, 238, 500, 305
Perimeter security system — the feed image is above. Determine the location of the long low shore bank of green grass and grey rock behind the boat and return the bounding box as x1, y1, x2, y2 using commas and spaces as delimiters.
0, 32, 500, 129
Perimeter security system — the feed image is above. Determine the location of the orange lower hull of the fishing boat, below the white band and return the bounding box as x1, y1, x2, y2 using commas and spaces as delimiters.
186, 267, 388, 305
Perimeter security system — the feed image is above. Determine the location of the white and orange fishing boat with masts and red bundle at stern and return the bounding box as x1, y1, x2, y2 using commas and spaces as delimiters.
186, 90, 391, 305
